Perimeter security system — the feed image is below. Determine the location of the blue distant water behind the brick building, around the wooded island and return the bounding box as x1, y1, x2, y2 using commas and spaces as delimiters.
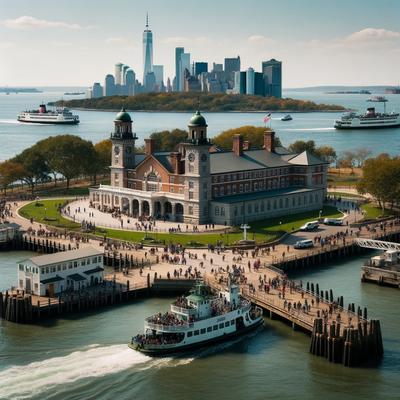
0, 91, 400, 160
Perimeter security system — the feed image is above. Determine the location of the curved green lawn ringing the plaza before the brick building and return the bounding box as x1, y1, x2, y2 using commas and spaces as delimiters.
20, 199, 342, 245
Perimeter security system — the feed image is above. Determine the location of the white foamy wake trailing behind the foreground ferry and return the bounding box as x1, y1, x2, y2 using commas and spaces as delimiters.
0, 344, 193, 399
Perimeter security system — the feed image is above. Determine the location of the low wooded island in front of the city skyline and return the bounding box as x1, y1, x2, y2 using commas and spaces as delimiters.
49, 92, 345, 112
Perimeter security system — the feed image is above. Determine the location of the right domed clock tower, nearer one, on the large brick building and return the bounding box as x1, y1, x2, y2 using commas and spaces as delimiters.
182, 111, 211, 224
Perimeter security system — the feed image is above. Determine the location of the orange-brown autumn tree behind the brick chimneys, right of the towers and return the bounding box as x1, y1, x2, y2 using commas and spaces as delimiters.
213, 125, 281, 149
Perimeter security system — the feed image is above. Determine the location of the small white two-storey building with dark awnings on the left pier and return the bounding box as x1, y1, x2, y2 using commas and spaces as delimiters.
18, 247, 104, 297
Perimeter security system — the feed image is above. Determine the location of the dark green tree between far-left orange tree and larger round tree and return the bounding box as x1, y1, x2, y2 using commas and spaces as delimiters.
11, 146, 50, 194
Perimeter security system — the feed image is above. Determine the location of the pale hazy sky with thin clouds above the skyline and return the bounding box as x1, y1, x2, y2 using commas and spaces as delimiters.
0, 0, 400, 88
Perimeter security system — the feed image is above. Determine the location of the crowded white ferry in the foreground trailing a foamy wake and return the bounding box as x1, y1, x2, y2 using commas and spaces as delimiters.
129, 282, 263, 355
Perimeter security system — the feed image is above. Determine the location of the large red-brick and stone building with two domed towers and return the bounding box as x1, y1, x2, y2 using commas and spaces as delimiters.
90, 110, 328, 225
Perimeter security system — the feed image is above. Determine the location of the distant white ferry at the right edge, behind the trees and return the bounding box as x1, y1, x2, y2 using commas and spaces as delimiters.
334, 96, 400, 129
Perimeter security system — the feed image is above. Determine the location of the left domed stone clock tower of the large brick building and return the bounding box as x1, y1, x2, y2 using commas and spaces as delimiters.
111, 108, 137, 187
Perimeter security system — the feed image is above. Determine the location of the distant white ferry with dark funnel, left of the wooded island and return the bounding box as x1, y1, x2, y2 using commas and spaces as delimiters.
17, 104, 79, 125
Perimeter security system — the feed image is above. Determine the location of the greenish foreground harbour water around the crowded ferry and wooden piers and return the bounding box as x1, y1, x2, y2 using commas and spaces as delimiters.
0, 252, 400, 400
